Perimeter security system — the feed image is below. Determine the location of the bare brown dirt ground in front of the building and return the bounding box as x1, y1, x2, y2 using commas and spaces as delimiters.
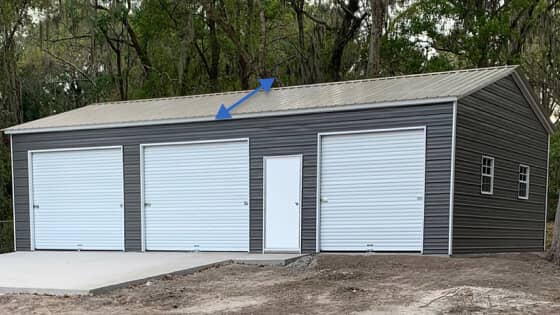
0, 254, 560, 315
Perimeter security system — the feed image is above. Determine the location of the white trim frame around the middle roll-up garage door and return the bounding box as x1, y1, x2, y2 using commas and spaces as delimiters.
138, 137, 251, 252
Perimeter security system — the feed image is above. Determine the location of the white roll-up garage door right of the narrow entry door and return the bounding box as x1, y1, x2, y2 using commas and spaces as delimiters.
319, 128, 426, 251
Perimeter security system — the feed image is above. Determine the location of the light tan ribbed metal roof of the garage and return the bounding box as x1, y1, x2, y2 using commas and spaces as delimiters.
5, 66, 528, 133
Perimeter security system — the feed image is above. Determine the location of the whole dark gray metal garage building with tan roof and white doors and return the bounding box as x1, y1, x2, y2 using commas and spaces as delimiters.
5, 66, 552, 254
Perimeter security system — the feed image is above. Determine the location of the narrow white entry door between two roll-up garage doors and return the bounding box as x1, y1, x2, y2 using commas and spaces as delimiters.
264, 155, 302, 251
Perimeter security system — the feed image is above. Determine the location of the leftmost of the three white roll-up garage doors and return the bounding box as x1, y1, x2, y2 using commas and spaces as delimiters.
30, 147, 124, 250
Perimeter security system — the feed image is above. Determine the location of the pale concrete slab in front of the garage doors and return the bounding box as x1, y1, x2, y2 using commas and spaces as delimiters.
0, 251, 301, 295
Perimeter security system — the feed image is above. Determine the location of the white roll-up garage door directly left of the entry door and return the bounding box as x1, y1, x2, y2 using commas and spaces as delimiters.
143, 140, 249, 251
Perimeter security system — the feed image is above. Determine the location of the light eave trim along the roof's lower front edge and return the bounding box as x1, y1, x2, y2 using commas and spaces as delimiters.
3, 96, 457, 134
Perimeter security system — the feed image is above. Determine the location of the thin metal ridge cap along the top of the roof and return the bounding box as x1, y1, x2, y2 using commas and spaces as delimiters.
88, 65, 519, 107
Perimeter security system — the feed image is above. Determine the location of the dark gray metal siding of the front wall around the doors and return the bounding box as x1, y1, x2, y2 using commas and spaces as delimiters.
13, 103, 452, 254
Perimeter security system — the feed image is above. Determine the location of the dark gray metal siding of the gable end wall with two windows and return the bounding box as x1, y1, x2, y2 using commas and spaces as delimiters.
453, 77, 548, 254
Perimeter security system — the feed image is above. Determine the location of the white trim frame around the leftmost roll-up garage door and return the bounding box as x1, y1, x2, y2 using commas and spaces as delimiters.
27, 145, 126, 251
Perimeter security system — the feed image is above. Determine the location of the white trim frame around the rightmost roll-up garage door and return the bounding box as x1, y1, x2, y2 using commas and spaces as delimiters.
315, 125, 428, 254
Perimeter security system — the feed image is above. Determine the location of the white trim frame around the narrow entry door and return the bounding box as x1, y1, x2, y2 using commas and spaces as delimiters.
262, 154, 303, 253
